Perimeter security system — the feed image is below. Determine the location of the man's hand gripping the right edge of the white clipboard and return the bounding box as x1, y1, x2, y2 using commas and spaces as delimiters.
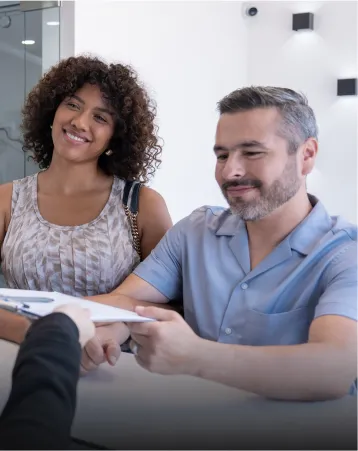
127, 307, 203, 374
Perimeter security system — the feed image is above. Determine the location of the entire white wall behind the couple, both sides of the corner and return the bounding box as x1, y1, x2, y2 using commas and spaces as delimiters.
70, 1, 358, 222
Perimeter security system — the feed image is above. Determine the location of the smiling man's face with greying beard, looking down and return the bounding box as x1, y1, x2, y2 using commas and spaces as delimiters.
214, 108, 309, 221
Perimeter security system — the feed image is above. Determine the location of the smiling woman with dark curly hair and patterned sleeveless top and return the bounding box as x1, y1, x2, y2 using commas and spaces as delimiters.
0, 56, 172, 341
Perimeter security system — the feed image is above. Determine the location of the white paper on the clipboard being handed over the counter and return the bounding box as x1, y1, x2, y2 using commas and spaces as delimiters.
0, 288, 154, 323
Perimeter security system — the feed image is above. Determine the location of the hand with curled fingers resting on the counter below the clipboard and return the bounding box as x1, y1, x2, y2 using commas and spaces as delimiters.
81, 323, 129, 375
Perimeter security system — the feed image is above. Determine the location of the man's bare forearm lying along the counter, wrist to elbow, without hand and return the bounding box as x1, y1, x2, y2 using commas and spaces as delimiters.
189, 340, 356, 401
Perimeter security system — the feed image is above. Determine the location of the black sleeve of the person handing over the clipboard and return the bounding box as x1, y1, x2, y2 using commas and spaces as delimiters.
0, 313, 81, 449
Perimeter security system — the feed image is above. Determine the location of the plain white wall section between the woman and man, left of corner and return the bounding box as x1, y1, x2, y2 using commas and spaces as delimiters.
75, 1, 246, 221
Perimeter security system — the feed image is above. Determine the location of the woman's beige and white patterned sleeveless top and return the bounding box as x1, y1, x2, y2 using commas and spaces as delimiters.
1, 174, 140, 296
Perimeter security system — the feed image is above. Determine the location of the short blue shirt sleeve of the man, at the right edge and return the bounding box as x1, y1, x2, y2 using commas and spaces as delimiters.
315, 241, 357, 321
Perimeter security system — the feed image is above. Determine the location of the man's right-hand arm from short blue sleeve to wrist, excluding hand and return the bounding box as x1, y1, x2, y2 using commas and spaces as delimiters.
190, 247, 357, 400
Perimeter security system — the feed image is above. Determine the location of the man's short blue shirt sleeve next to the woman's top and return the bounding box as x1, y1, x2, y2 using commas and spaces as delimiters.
134, 219, 185, 300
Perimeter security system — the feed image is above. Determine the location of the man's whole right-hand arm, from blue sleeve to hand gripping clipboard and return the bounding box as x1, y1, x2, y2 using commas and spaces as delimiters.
129, 247, 357, 401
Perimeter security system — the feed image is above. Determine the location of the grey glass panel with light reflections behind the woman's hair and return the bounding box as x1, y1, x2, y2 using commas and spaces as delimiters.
0, 1, 60, 184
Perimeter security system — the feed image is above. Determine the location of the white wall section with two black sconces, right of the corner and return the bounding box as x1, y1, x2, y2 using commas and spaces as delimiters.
246, 1, 358, 222
